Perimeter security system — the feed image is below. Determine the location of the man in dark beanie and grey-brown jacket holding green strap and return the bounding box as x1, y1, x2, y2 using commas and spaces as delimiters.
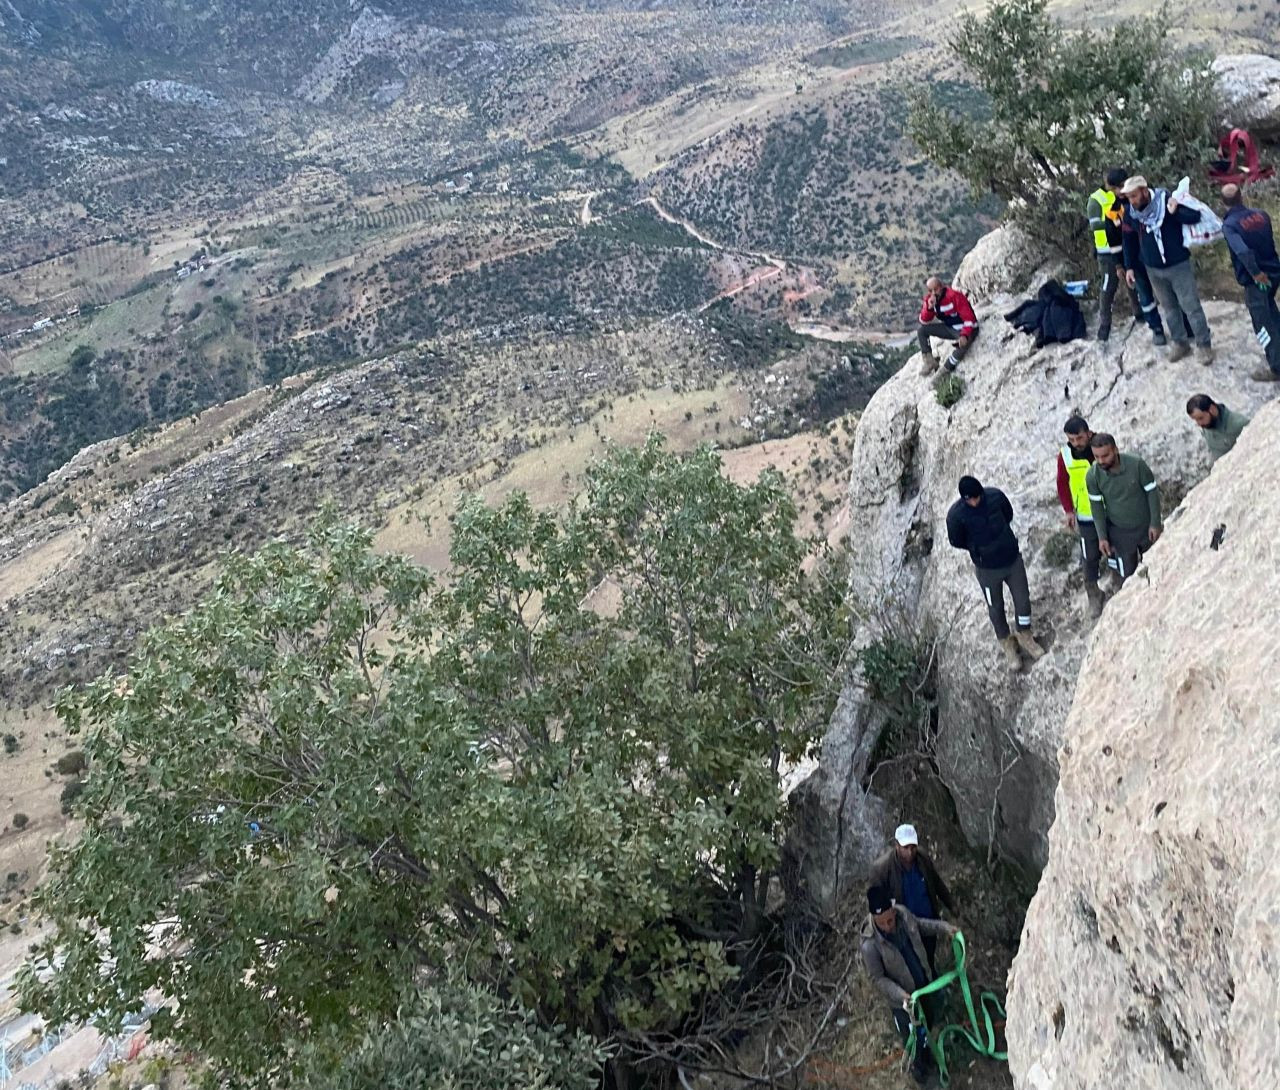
861, 885, 959, 1085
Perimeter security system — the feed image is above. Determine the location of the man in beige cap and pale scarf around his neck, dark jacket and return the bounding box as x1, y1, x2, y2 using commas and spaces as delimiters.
1121, 174, 1213, 363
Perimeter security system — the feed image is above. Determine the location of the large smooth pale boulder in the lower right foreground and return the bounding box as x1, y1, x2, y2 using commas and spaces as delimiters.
1009, 404, 1280, 1090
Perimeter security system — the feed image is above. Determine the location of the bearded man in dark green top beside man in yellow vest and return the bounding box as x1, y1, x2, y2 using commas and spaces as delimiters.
1084, 431, 1164, 583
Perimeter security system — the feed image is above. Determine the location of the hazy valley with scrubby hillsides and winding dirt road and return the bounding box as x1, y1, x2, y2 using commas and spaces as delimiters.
0, 0, 1280, 1086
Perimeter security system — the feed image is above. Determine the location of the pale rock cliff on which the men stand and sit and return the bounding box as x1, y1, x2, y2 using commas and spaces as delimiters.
796, 229, 1271, 903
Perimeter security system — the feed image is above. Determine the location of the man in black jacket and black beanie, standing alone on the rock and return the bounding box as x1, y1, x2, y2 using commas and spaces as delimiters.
947, 477, 1044, 673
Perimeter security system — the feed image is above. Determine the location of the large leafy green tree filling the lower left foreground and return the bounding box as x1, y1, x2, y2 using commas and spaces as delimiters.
22, 439, 849, 1086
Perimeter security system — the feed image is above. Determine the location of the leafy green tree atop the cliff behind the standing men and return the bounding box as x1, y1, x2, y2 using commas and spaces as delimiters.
908, 0, 1221, 247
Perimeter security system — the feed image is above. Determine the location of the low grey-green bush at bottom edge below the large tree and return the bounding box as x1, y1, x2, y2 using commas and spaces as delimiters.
294, 985, 604, 1090
